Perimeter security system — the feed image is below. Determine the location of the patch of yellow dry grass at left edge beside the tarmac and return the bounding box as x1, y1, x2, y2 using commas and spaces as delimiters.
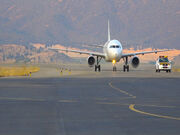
0, 66, 40, 77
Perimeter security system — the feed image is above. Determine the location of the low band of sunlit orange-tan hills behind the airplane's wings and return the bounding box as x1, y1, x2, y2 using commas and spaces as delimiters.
0, 44, 180, 65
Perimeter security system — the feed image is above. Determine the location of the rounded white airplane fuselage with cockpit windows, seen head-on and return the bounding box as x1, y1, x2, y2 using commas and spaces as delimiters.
103, 40, 123, 62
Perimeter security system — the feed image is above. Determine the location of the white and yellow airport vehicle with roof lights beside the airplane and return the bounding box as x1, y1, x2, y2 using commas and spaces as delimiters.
156, 56, 172, 73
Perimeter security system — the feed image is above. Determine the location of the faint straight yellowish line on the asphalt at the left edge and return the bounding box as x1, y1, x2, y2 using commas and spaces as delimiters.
0, 97, 46, 102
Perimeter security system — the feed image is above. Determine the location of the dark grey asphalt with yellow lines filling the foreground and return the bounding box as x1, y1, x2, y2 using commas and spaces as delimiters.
0, 77, 180, 135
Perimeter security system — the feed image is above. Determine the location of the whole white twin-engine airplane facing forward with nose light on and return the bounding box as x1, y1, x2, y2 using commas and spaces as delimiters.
49, 21, 168, 72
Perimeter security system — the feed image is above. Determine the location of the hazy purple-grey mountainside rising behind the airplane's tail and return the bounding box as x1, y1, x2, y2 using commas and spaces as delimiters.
0, 0, 180, 49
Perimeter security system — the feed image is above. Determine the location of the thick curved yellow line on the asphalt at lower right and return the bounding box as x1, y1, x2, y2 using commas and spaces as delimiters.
129, 104, 180, 120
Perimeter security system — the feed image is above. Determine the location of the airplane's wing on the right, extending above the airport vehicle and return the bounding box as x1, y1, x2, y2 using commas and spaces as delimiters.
122, 50, 170, 57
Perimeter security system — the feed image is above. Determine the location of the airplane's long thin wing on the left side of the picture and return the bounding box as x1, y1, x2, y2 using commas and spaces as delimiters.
48, 48, 105, 58
